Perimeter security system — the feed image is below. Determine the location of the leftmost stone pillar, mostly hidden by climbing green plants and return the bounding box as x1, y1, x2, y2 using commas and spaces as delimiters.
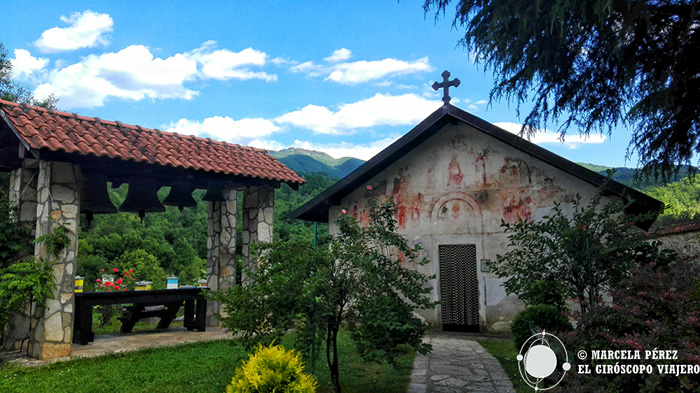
3, 168, 38, 350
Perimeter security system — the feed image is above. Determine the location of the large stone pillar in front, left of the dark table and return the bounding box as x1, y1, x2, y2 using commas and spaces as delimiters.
30, 161, 80, 359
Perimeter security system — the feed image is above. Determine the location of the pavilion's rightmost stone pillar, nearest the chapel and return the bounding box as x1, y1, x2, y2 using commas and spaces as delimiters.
241, 186, 275, 283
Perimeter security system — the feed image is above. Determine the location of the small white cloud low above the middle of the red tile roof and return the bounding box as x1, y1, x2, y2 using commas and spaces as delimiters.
164, 116, 280, 148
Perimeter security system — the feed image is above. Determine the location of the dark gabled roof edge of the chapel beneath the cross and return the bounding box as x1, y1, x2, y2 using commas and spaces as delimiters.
290, 104, 663, 230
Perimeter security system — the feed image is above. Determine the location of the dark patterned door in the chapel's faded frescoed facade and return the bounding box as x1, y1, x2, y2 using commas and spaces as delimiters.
438, 244, 479, 332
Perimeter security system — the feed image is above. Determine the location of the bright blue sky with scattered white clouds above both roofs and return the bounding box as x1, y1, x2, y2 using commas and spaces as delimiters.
0, 0, 636, 166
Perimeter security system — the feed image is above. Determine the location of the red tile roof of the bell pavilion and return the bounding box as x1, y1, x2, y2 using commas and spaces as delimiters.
0, 100, 305, 185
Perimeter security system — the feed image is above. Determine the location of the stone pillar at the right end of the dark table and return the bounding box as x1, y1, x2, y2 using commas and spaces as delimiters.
207, 188, 237, 326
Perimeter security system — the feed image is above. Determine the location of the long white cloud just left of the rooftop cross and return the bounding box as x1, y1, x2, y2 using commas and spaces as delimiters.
274, 94, 441, 135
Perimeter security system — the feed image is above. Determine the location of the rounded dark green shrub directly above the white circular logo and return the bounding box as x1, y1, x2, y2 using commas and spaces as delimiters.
510, 304, 573, 350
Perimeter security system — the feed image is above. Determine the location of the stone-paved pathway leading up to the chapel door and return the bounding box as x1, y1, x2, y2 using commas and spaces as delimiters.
408, 332, 515, 393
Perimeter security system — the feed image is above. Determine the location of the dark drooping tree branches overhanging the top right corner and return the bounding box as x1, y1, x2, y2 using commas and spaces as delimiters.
423, 0, 700, 178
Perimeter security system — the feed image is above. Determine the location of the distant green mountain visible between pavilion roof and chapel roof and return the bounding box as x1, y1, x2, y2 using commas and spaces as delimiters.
269, 147, 365, 178
